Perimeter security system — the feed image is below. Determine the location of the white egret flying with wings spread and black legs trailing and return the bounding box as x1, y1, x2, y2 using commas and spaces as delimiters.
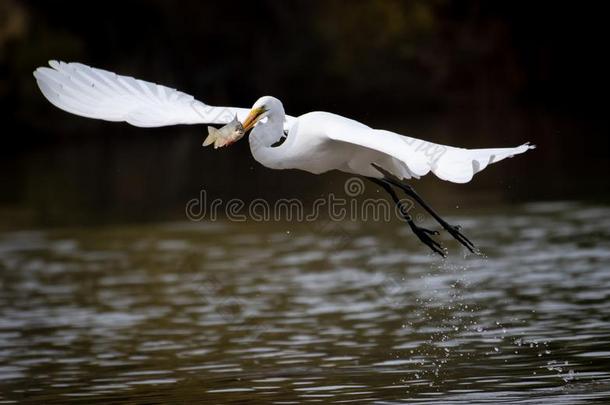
34, 61, 534, 257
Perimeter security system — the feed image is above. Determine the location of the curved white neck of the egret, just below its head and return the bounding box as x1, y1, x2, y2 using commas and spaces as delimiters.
248, 116, 285, 169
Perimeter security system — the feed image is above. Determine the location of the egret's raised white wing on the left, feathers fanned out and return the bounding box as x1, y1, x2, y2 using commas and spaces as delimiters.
34, 61, 292, 127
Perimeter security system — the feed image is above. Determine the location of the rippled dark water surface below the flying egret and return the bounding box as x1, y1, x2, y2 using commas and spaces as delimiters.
0, 202, 610, 404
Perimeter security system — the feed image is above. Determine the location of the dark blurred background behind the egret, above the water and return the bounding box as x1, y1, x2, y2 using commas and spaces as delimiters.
0, 0, 610, 228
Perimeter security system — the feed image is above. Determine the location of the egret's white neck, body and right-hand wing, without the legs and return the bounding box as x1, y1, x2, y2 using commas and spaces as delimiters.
250, 106, 530, 183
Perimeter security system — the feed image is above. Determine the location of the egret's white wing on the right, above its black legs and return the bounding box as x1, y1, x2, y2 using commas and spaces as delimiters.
327, 116, 535, 183
